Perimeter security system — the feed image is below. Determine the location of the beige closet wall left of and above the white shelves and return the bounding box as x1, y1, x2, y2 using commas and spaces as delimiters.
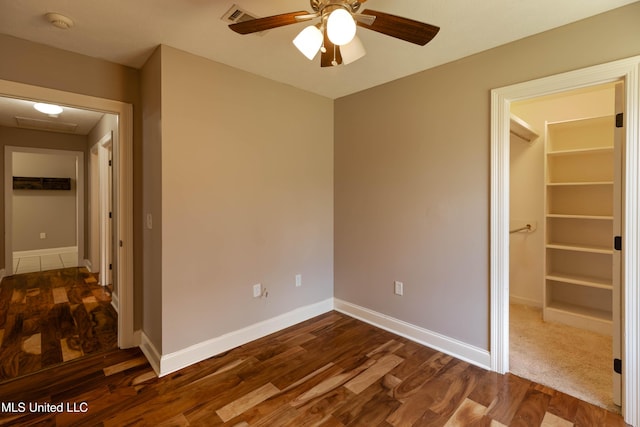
509, 84, 615, 307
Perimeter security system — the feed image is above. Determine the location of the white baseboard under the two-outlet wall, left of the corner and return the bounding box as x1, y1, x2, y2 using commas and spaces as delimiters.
151, 298, 333, 377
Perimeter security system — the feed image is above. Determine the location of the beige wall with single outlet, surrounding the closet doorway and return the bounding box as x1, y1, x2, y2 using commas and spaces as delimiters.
334, 3, 640, 349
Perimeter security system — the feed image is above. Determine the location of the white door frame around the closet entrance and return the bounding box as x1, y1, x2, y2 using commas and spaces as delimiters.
490, 56, 640, 425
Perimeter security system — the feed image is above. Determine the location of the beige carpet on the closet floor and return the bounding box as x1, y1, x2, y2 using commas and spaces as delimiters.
509, 304, 620, 413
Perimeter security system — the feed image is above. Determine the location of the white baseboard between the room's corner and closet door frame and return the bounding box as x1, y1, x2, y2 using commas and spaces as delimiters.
334, 298, 490, 369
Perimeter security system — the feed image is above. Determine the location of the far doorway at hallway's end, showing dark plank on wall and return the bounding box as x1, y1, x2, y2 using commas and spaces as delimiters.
4, 147, 85, 274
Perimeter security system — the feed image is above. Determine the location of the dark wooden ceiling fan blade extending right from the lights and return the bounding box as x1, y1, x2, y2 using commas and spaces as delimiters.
357, 9, 440, 46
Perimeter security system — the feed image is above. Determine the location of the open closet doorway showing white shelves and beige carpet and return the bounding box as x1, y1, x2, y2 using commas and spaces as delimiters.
509, 82, 623, 412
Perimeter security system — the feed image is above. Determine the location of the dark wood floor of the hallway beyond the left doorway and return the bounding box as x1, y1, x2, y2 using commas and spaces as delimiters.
0, 267, 117, 382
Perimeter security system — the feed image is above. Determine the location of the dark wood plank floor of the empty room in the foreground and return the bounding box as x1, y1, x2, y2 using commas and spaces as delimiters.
0, 312, 625, 427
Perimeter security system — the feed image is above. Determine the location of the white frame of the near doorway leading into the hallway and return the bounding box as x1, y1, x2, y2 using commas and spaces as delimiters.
0, 80, 135, 348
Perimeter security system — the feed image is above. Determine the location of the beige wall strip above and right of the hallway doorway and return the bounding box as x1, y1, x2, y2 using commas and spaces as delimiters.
0, 34, 142, 328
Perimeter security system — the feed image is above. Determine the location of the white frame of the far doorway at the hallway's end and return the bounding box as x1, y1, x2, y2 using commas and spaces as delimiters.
4, 145, 85, 275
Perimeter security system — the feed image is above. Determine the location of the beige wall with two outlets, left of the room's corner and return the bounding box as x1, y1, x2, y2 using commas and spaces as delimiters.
144, 46, 333, 354
